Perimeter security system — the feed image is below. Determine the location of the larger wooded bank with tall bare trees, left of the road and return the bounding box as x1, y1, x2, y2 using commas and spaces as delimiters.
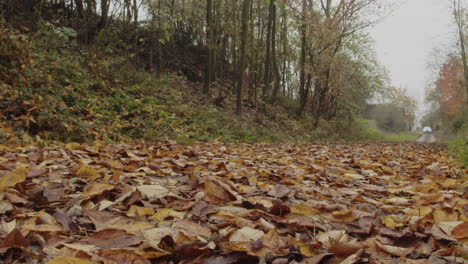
0, 0, 426, 142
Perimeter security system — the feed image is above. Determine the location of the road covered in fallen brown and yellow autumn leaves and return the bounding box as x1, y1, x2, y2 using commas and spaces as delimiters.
0, 143, 468, 264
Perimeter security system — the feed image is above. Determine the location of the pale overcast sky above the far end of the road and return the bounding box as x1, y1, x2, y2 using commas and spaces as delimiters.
369, 0, 455, 114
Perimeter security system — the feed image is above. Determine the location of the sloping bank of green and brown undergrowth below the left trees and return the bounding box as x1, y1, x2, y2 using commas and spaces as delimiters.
0, 20, 404, 143
